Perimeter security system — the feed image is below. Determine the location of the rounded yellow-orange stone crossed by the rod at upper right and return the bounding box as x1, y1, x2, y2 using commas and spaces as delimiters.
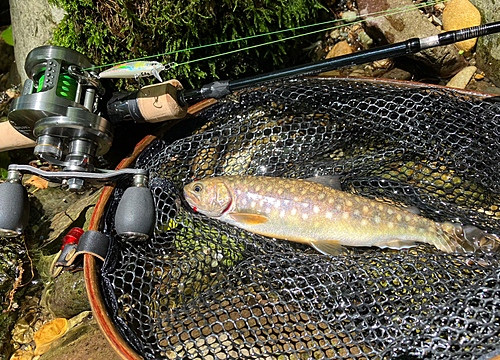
443, 0, 481, 52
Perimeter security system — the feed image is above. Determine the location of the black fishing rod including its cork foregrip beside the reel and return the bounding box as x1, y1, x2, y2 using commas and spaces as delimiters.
107, 22, 500, 123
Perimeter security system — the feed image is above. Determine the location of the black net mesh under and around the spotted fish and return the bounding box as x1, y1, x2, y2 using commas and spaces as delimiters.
98, 79, 500, 359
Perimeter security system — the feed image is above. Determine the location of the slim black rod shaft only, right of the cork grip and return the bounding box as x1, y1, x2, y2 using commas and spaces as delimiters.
178, 21, 500, 106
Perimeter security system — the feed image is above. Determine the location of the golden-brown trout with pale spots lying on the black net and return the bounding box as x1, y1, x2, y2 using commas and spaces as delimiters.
184, 176, 484, 255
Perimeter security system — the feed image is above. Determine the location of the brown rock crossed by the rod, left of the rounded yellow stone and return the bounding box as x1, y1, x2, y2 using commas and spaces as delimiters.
357, 0, 466, 77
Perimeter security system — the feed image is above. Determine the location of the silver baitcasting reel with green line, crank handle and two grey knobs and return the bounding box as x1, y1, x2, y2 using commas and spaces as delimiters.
0, 46, 154, 239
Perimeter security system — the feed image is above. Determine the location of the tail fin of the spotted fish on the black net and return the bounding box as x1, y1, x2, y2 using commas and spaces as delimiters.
434, 222, 500, 253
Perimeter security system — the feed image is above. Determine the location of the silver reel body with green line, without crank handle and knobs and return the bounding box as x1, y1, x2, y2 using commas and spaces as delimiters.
9, 45, 113, 179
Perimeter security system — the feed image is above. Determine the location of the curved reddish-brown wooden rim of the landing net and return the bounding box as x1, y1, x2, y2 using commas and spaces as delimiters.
83, 100, 217, 360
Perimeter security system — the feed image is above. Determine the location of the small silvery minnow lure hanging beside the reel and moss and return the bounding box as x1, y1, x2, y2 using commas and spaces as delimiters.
99, 61, 173, 82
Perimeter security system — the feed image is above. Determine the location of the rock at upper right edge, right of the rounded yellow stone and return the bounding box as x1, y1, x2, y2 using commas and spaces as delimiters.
471, 0, 500, 87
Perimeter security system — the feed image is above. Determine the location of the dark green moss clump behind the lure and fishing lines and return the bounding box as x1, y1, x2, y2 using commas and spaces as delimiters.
47, 0, 325, 86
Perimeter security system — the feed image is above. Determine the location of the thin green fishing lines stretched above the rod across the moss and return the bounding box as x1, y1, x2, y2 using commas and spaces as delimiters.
82, 0, 449, 71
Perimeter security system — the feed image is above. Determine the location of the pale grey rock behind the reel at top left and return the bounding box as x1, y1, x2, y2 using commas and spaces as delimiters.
10, 0, 64, 83
